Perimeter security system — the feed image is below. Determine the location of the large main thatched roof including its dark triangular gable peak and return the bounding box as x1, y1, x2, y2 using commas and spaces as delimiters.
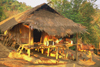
0, 3, 86, 36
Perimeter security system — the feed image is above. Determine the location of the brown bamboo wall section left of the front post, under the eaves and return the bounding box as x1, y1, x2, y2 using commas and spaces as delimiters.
9, 23, 33, 44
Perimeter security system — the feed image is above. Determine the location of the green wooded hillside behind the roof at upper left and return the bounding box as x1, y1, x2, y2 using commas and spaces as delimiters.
0, 0, 31, 21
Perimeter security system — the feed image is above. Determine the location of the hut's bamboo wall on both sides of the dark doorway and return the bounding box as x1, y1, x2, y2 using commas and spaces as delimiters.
9, 23, 49, 44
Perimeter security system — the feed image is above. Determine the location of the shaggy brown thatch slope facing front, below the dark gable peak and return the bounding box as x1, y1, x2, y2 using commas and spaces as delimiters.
24, 9, 85, 36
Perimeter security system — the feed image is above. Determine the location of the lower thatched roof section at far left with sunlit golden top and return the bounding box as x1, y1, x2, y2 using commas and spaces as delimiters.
0, 10, 28, 31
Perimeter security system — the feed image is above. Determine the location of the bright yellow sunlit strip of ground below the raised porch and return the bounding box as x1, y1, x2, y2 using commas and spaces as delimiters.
8, 52, 67, 64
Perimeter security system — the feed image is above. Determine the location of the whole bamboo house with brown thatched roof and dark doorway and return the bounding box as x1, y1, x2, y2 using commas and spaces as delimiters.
0, 3, 86, 61
